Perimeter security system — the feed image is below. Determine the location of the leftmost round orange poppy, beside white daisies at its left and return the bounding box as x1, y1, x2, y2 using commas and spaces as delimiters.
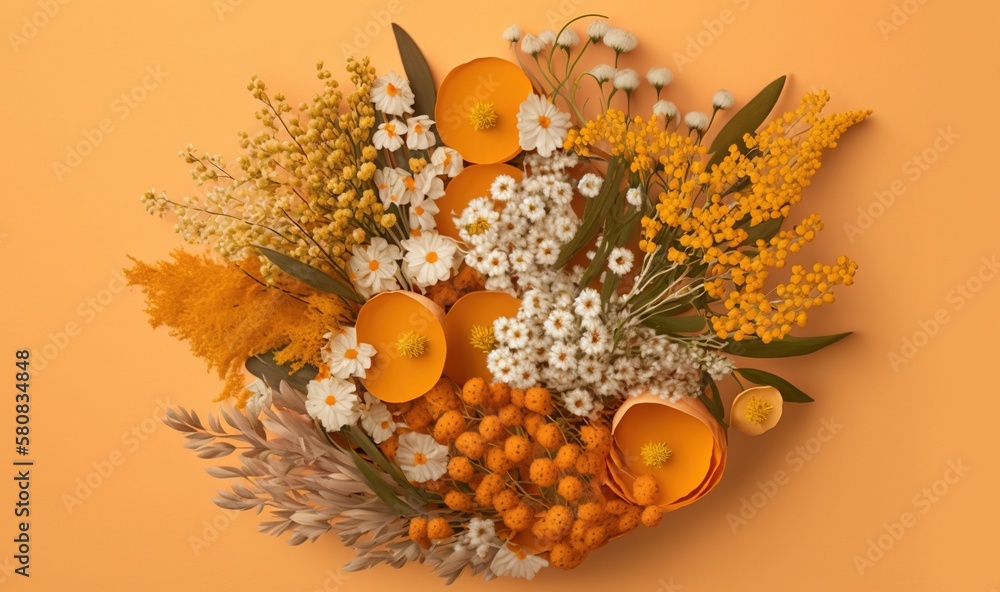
356, 290, 448, 403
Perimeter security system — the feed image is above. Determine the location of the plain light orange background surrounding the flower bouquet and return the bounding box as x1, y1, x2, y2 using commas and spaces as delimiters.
0, 0, 1000, 592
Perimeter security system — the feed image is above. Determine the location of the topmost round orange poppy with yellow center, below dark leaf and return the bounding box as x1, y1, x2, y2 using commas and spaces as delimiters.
434, 58, 532, 164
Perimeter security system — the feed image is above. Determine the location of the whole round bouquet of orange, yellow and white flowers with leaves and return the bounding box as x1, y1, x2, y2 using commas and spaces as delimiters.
128, 15, 868, 581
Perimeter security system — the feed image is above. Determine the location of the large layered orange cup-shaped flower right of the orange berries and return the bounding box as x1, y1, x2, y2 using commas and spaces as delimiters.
606, 394, 726, 511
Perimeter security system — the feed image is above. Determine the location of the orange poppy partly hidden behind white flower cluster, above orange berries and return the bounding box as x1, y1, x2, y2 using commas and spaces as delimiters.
444, 291, 521, 384
